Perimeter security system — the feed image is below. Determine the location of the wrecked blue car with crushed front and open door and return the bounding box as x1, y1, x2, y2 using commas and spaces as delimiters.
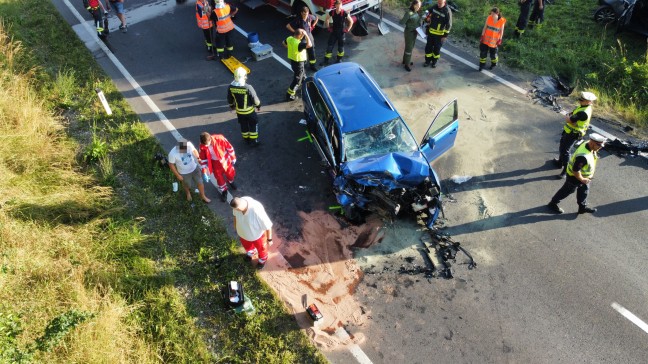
302, 62, 459, 228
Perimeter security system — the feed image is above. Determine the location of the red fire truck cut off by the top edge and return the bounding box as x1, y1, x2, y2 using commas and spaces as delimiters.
242, 0, 382, 26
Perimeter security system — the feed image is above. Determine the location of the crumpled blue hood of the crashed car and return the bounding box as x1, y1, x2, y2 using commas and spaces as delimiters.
341, 151, 430, 190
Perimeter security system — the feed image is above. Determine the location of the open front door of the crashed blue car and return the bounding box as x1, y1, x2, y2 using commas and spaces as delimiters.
421, 99, 459, 162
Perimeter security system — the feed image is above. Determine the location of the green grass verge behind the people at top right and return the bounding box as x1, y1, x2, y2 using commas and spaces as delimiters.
396, 0, 648, 132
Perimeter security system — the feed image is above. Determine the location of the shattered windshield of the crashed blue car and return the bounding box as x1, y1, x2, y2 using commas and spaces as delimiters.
342, 118, 418, 161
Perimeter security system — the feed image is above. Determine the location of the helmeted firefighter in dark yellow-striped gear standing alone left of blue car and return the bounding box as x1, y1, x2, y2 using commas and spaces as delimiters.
227, 67, 261, 145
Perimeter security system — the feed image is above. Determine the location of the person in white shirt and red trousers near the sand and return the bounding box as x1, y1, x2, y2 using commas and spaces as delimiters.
230, 196, 272, 269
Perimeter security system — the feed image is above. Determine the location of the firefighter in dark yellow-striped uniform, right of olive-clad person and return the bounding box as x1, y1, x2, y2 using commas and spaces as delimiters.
423, 0, 452, 68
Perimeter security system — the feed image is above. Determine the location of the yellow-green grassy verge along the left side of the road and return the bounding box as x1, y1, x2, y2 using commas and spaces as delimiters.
0, 0, 325, 363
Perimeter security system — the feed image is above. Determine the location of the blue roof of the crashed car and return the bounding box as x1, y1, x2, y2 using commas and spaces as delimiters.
313, 62, 400, 133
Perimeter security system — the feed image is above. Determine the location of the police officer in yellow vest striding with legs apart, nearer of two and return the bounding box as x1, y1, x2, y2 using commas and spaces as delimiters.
547, 133, 606, 214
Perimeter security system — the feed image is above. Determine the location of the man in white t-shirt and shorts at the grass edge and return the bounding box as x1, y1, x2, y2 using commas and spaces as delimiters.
168, 139, 211, 203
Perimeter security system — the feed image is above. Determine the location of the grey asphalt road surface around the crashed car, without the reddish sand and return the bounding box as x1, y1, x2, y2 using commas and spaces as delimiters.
53, 0, 648, 363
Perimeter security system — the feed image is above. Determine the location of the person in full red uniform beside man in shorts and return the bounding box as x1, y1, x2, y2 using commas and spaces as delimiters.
199, 132, 236, 202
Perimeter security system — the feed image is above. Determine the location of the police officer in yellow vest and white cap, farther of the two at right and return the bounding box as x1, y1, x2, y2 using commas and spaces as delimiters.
554, 92, 596, 178
